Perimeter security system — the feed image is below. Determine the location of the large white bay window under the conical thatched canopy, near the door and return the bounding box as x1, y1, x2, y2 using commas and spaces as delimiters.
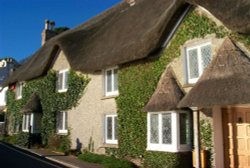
147, 111, 191, 152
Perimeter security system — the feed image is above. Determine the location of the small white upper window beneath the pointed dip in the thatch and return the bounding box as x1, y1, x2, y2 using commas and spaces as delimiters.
57, 69, 69, 92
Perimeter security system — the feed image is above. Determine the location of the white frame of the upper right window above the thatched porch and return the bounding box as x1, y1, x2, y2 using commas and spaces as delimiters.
185, 42, 212, 84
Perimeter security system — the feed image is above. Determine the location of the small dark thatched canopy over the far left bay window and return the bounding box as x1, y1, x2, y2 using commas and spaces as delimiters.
21, 93, 42, 113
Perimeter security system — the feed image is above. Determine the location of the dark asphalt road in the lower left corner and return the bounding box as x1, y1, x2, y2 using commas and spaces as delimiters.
0, 142, 66, 168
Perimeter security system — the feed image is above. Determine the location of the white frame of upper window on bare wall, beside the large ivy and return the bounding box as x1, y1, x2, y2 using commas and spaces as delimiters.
104, 66, 119, 96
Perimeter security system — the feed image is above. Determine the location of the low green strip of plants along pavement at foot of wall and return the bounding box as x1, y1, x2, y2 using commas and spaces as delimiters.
78, 152, 135, 168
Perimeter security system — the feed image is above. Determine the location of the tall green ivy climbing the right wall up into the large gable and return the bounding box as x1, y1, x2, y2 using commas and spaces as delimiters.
116, 7, 250, 167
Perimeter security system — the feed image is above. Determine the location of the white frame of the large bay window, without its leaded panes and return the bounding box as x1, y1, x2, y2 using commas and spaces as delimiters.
147, 111, 191, 152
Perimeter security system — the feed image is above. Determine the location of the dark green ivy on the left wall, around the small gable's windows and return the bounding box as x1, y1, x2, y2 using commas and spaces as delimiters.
7, 71, 89, 145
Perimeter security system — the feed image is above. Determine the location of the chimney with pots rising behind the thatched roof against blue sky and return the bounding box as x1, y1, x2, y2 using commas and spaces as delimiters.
42, 19, 57, 46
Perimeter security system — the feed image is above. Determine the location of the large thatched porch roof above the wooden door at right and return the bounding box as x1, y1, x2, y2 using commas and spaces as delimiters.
178, 38, 250, 107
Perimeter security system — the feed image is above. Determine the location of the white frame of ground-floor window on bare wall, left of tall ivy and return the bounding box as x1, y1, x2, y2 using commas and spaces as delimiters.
105, 114, 118, 144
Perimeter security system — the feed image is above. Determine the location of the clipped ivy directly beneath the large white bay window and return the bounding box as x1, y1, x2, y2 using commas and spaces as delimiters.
143, 152, 192, 168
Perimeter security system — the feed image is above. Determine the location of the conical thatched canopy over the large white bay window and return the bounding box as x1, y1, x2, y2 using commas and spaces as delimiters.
143, 67, 184, 112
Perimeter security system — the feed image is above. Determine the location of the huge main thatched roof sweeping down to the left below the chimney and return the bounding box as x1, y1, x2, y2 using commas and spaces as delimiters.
4, 0, 186, 85
